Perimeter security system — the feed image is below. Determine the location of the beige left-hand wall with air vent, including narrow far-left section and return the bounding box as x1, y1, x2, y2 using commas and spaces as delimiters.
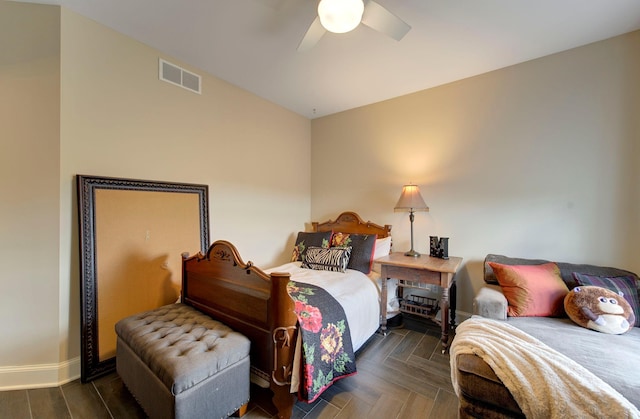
0, 2, 311, 389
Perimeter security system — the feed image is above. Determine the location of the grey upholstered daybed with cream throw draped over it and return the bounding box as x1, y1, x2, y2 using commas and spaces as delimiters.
451, 254, 640, 418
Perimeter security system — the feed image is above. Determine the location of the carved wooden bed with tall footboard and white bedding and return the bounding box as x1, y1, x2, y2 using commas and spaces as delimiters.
182, 212, 393, 418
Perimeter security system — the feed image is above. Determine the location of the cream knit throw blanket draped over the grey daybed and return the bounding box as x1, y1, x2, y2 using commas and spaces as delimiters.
450, 316, 640, 419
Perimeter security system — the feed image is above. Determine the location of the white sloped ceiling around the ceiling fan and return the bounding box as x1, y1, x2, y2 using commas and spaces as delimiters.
15, 0, 640, 118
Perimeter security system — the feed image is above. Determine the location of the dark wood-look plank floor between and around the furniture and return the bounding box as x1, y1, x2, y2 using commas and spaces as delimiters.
0, 317, 458, 419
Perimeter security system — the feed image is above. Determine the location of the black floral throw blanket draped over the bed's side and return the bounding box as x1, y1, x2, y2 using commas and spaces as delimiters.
287, 281, 356, 403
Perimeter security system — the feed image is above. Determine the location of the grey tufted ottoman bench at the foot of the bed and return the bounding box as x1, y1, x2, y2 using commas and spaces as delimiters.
115, 304, 250, 419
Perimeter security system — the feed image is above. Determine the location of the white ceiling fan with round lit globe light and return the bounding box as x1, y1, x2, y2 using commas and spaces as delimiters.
298, 0, 411, 51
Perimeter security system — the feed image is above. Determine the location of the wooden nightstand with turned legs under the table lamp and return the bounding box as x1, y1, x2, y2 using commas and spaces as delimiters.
375, 253, 462, 353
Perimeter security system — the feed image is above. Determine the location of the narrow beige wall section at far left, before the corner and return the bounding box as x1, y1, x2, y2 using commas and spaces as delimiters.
0, 1, 60, 388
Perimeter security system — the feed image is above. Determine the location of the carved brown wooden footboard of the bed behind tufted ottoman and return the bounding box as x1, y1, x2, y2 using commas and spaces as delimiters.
182, 240, 297, 418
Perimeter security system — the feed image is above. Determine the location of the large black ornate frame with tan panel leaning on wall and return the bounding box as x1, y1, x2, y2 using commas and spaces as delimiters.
76, 175, 209, 382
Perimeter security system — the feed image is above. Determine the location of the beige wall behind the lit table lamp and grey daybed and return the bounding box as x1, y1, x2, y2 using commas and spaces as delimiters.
311, 28, 640, 315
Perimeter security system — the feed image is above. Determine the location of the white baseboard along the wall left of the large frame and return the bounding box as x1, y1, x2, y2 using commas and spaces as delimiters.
0, 357, 80, 391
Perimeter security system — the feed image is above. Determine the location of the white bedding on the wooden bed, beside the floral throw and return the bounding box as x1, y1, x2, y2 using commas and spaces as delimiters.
265, 262, 390, 351
